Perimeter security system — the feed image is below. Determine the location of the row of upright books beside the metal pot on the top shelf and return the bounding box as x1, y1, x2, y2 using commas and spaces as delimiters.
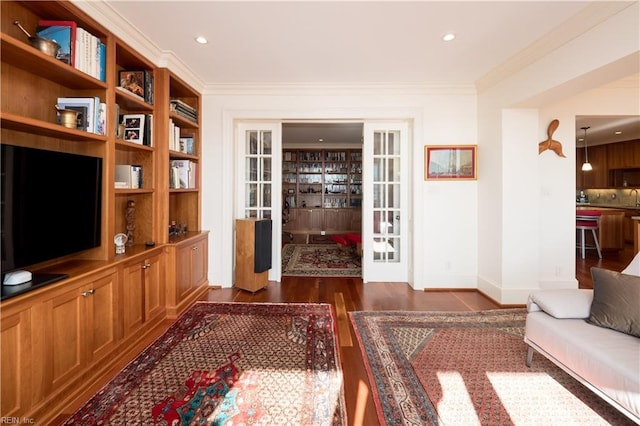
36, 20, 107, 81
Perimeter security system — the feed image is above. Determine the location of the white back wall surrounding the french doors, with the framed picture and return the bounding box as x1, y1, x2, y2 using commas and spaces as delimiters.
202, 87, 477, 288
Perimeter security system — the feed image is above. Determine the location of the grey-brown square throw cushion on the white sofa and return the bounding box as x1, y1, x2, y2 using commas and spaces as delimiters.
587, 267, 640, 337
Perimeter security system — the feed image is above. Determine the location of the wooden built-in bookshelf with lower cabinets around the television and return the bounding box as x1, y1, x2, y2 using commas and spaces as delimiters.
0, 1, 208, 421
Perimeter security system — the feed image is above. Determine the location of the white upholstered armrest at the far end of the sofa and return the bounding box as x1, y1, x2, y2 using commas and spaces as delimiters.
527, 289, 593, 319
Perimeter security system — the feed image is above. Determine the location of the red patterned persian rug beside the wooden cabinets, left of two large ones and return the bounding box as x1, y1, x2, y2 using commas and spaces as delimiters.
64, 302, 346, 425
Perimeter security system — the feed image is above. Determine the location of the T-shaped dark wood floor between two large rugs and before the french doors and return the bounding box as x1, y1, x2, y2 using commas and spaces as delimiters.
208, 277, 499, 425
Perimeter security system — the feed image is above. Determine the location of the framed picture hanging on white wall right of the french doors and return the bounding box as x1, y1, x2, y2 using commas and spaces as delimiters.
424, 145, 478, 180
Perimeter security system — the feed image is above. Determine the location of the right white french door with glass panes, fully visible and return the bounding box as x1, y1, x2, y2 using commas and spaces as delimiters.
362, 122, 410, 282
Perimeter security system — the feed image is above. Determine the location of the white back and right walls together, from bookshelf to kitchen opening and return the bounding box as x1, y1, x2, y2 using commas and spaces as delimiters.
202, 3, 639, 296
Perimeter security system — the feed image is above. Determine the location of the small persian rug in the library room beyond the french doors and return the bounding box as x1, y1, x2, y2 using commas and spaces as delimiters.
282, 244, 362, 277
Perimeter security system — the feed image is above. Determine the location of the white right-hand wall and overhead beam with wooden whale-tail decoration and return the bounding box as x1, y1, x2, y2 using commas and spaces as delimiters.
478, 3, 640, 304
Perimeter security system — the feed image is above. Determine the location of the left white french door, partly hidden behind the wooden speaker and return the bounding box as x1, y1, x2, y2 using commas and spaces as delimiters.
236, 122, 282, 281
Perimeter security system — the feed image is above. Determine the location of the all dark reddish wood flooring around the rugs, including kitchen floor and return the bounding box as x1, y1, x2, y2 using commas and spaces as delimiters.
54, 247, 633, 426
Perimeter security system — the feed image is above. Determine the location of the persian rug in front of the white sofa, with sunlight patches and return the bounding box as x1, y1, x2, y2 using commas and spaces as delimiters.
350, 309, 633, 425
